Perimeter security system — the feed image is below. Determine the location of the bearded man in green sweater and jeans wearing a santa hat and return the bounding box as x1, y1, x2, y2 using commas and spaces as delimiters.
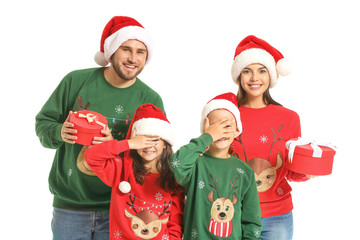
36, 17, 164, 240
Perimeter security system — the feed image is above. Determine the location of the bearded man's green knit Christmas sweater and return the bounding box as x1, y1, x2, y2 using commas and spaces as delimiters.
35, 68, 164, 210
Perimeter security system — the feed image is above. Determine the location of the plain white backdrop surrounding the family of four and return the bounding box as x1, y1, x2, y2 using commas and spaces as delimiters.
0, 0, 360, 240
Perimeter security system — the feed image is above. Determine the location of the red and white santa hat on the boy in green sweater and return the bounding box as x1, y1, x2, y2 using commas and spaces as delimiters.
200, 92, 242, 134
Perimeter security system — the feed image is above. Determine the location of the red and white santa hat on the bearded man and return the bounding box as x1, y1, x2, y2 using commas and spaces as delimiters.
94, 16, 153, 67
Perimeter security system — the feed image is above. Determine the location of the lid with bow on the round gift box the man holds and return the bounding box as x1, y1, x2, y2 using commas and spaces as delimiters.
70, 110, 107, 133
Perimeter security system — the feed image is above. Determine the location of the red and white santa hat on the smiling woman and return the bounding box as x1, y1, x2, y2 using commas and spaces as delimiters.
231, 35, 292, 87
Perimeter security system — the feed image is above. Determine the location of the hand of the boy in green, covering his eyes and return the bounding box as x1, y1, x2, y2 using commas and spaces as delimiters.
204, 118, 237, 142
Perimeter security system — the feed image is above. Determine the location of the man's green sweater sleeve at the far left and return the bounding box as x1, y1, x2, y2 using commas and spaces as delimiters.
35, 74, 78, 149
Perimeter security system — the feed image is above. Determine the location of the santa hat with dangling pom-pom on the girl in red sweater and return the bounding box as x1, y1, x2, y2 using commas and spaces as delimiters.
119, 103, 174, 193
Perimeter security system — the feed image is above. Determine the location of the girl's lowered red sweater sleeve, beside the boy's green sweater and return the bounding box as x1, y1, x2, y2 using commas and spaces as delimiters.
167, 186, 185, 240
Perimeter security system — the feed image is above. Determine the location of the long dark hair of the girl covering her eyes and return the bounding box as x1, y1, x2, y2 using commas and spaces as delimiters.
130, 141, 179, 192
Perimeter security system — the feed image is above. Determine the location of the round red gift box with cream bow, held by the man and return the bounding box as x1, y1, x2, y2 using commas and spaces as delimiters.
70, 110, 107, 146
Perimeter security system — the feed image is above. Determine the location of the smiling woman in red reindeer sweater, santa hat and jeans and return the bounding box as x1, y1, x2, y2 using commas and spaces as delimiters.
232, 36, 309, 240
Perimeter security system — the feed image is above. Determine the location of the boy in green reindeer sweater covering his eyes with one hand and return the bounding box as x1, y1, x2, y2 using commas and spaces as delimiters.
170, 93, 261, 240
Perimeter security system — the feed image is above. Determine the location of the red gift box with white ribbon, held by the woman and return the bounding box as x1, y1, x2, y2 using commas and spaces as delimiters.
285, 138, 336, 176
